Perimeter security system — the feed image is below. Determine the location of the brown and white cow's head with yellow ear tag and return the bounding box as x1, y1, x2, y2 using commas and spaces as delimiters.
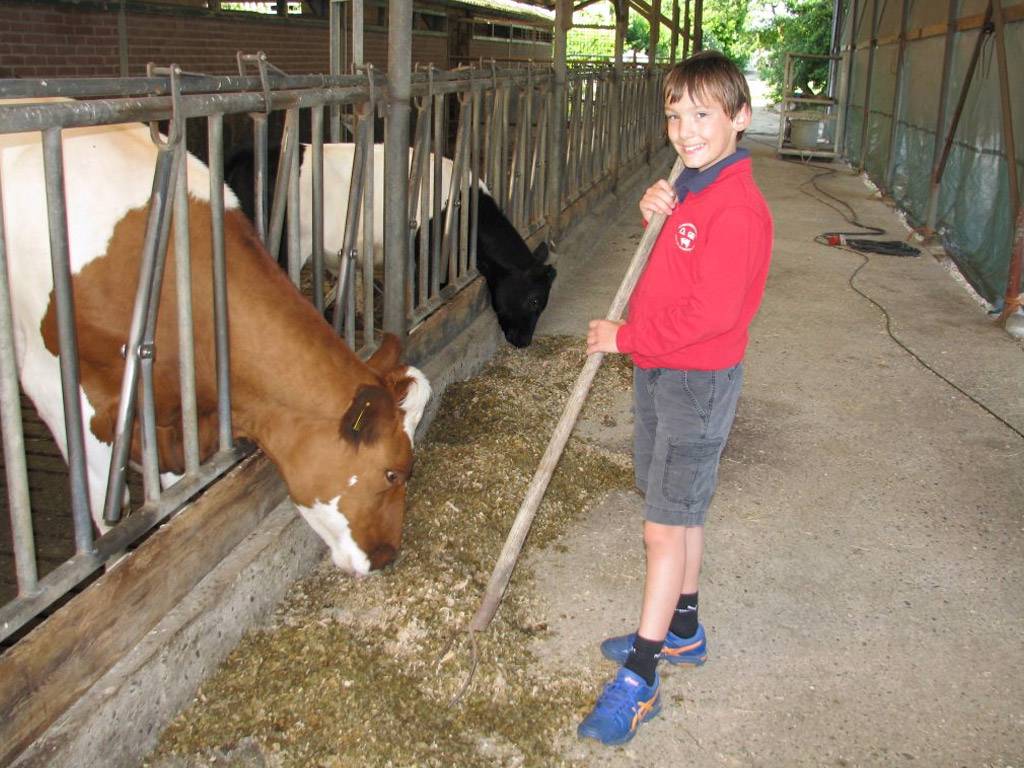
274, 336, 430, 575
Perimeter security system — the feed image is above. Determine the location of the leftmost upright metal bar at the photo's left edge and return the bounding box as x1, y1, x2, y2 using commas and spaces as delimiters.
0, 166, 39, 596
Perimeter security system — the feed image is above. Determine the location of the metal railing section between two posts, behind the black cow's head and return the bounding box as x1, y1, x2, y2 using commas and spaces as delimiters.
407, 63, 551, 326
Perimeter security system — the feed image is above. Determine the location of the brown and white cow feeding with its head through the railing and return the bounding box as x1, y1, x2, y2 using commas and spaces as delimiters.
0, 102, 430, 574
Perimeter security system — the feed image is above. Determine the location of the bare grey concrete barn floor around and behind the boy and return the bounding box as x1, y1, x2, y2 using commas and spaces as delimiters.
532, 114, 1024, 768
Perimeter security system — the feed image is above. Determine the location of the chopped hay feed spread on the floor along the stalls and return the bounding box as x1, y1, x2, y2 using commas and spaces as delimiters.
147, 337, 632, 768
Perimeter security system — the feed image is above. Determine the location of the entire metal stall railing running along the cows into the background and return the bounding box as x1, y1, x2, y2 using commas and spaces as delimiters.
0, 54, 660, 651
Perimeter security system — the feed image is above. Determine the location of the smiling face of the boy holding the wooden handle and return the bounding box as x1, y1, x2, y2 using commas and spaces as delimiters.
665, 91, 751, 171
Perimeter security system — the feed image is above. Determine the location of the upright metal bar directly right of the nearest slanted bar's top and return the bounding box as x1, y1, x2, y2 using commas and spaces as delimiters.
174, 141, 200, 476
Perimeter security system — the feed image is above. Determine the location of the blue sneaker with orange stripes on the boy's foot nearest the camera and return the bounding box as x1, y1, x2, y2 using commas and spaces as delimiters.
577, 667, 662, 745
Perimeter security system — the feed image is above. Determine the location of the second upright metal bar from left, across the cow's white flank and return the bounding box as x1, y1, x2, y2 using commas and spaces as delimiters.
43, 128, 92, 552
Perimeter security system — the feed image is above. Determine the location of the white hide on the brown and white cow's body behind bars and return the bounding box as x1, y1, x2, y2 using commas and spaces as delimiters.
0, 99, 238, 530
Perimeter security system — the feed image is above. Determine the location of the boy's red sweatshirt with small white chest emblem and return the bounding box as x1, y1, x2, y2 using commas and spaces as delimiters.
615, 158, 772, 371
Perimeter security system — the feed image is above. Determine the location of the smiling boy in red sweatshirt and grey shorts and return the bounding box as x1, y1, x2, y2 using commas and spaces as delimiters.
578, 51, 772, 744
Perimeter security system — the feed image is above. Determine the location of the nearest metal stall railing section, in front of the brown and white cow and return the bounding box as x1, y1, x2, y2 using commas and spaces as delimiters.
0, 69, 387, 640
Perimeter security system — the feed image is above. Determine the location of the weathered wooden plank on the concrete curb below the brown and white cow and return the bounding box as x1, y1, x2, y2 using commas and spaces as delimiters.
0, 453, 286, 765
